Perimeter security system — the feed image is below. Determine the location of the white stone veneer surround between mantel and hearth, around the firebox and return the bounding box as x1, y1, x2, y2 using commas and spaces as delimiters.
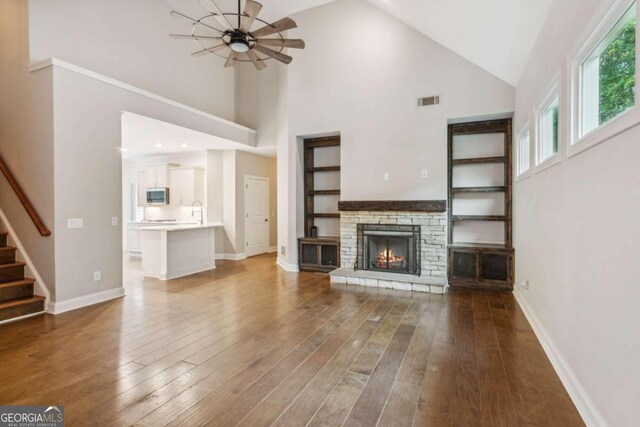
340, 211, 447, 280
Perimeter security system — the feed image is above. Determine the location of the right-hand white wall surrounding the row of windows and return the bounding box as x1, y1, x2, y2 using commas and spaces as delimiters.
514, 0, 640, 426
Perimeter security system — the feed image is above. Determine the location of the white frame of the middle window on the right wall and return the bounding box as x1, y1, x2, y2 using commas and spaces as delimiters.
533, 78, 564, 173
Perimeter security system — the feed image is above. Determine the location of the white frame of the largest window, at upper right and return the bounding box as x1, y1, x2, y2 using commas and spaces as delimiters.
566, 0, 640, 157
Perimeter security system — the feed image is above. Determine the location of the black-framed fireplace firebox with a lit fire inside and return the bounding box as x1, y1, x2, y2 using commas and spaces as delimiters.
355, 224, 420, 276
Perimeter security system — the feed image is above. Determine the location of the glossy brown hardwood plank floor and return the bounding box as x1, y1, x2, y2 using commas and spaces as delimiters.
0, 256, 583, 426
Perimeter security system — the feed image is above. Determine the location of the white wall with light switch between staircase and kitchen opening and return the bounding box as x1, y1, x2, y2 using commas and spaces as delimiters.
45, 61, 252, 302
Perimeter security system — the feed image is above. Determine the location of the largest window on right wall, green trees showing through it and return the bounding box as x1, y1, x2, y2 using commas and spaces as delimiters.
578, 2, 637, 137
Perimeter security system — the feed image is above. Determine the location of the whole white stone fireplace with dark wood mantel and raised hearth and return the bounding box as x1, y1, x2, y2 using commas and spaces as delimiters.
331, 201, 447, 293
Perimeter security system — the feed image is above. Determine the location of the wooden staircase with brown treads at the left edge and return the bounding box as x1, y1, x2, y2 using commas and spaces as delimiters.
0, 232, 45, 322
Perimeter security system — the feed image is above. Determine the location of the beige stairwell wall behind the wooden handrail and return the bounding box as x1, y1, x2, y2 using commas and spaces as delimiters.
0, 0, 56, 298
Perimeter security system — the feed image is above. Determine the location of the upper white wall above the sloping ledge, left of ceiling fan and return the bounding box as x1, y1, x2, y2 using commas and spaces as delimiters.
29, 0, 235, 120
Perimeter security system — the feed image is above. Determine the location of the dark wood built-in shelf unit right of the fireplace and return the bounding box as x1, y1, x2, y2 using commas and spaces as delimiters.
448, 119, 514, 290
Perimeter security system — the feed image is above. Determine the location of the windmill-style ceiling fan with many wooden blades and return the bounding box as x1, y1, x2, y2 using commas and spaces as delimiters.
170, 0, 305, 70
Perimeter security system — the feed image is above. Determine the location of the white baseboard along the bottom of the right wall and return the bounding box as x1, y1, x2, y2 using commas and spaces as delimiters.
513, 290, 607, 427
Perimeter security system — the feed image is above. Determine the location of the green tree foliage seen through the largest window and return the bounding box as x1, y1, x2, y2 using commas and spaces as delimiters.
599, 19, 636, 124
